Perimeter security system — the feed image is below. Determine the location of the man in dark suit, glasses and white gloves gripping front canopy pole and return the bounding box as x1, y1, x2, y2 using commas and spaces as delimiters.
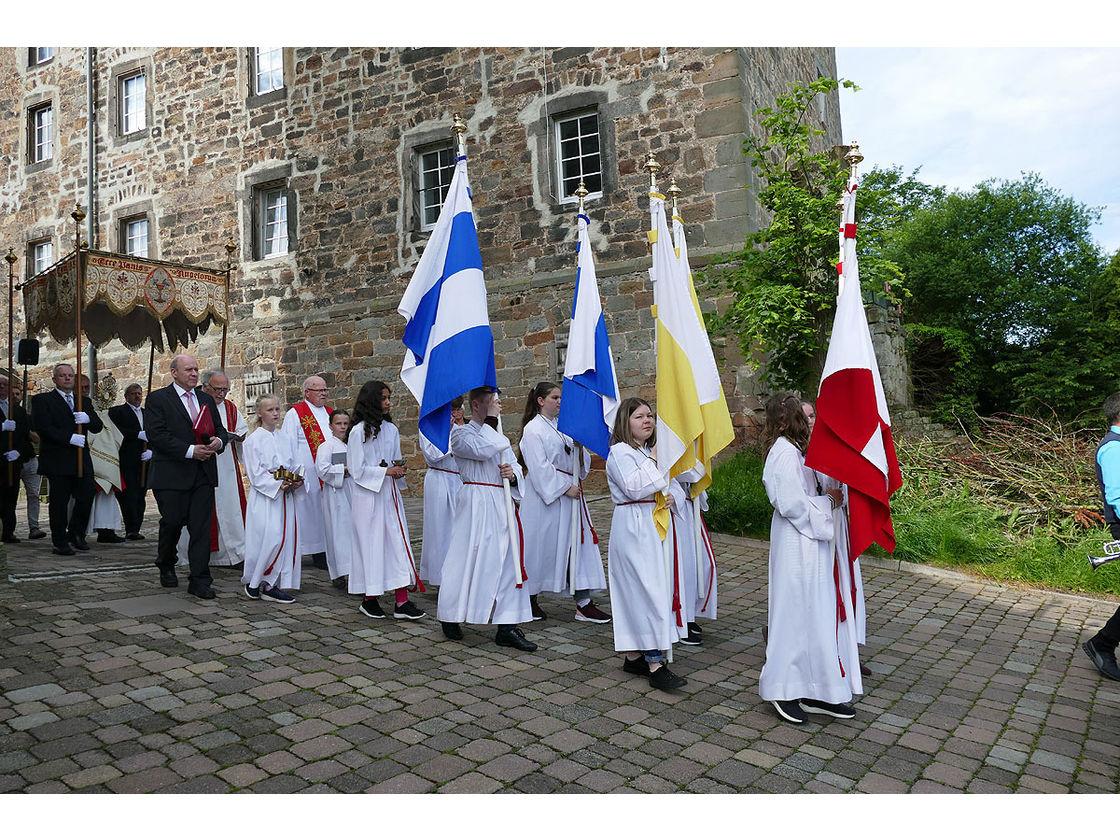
31, 363, 105, 554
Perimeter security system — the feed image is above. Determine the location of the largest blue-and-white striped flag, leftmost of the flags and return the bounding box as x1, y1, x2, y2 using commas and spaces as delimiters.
396, 156, 497, 452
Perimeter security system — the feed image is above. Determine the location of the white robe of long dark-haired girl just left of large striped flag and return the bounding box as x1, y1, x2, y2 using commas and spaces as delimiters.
346, 420, 417, 597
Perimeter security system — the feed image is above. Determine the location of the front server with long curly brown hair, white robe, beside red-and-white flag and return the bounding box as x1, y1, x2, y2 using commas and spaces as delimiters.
758, 391, 864, 724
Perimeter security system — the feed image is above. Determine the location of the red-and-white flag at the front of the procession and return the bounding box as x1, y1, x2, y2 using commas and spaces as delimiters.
805, 176, 903, 558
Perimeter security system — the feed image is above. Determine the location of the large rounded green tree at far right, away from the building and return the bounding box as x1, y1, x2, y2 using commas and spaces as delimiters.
885, 174, 1120, 414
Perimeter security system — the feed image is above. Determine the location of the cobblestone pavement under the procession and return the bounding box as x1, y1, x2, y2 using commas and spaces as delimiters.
0, 500, 1120, 793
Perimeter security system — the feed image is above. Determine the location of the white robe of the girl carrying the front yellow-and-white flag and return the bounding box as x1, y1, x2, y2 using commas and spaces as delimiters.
607, 442, 680, 651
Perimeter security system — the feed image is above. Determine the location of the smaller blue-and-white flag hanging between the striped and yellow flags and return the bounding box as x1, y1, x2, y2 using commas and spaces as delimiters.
557, 213, 618, 458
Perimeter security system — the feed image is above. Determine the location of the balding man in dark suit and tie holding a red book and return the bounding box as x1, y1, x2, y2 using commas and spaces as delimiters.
144, 354, 230, 598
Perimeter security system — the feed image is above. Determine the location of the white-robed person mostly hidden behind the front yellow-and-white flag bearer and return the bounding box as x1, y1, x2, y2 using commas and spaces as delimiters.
669, 465, 717, 645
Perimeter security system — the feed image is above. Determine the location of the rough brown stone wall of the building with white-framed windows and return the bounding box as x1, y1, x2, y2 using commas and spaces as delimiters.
0, 47, 841, 456
